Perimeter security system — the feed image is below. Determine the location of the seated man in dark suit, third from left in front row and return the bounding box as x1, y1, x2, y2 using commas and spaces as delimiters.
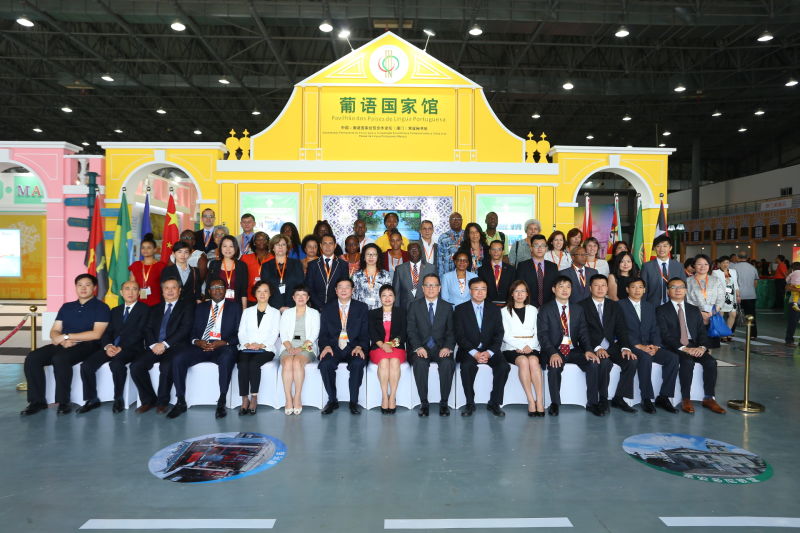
131, 278, 194, 414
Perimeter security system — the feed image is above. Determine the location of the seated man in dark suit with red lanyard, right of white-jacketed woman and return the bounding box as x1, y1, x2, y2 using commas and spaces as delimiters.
536, 276, 604, 416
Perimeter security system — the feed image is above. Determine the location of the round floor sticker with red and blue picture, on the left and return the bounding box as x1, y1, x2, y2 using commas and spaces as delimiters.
147, 432, 286, 483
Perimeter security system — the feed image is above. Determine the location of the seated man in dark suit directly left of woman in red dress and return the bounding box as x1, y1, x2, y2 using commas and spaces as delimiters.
318, 276, 370, 415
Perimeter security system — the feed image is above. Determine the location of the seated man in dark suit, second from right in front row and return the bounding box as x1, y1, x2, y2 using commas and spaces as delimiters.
619, 278, 678, 415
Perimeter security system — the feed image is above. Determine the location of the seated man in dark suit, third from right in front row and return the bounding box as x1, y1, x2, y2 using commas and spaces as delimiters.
578, 274, 636, 413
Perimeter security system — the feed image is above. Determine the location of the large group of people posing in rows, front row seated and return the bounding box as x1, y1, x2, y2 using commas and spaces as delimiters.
22, 210, 725, 418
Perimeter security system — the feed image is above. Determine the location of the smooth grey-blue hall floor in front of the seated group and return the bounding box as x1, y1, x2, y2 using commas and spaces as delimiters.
0, 314, 800, 533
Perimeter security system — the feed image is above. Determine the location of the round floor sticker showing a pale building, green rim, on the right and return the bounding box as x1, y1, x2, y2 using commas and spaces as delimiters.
622, 433, 772, 485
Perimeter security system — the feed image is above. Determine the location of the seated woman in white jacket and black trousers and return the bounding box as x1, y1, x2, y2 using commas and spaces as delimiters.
238, 281, 281, 416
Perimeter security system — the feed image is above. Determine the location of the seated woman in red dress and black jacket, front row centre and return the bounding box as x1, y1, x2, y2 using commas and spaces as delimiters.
367, 285, 406, 415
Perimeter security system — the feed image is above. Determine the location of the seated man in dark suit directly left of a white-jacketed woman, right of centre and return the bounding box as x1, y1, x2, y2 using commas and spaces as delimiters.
453, 278, 510, 417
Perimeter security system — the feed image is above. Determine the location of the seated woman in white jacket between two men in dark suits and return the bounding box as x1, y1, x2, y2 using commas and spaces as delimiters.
501, 280, 546, 416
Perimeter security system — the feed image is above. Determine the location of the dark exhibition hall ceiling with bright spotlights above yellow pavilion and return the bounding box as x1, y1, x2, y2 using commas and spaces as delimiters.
0, 0, 800, 180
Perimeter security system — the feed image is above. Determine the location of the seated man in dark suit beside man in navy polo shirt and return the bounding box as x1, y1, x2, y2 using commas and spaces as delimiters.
78, 280, 150, 413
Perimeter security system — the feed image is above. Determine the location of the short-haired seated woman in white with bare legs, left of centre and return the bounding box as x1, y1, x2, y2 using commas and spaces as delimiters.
280, 284, 319, 415
